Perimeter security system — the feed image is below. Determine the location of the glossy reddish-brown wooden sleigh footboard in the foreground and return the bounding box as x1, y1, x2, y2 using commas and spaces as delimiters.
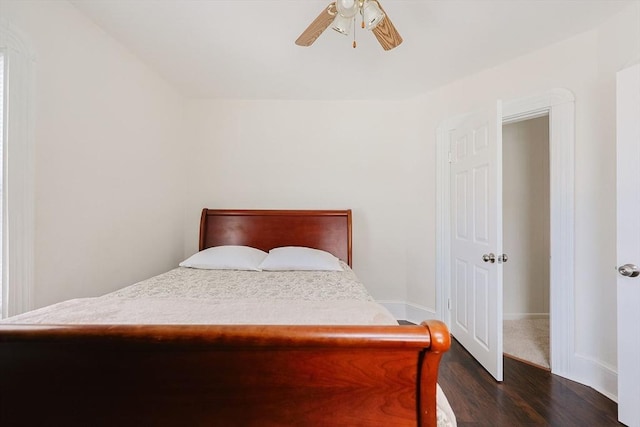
0, 321, 450, 426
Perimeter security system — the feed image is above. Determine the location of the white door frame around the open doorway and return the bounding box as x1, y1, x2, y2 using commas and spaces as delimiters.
436, 89, 575, 377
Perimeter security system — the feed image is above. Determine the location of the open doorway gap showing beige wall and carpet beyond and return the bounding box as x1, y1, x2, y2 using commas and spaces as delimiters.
502, 115, 551, 369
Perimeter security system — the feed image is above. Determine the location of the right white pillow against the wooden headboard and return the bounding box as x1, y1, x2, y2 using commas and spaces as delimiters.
260, 246, 342, 271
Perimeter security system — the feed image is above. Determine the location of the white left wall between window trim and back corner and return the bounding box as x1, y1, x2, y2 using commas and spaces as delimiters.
0, 1, 184, 307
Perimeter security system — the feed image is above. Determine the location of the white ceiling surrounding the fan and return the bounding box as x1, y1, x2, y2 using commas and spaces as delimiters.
71, 0, 640, 99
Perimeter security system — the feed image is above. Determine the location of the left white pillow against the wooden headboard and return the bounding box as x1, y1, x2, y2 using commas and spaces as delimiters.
179, 245, 267, 271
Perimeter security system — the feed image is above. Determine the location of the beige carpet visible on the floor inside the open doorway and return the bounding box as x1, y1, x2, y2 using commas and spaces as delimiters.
503, 319, 551, 369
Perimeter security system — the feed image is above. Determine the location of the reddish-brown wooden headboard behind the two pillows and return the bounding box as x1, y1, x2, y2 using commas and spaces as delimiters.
200, 208, 352, 266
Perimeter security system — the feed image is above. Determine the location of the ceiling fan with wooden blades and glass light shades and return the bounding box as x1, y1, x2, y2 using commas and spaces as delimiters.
296, 0, 402, 50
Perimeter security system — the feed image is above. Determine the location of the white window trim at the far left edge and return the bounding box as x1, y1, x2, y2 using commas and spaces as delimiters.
0, 23, 35, 317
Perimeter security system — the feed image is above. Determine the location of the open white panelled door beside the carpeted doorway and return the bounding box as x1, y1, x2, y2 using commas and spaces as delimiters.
448, 101, 502, 381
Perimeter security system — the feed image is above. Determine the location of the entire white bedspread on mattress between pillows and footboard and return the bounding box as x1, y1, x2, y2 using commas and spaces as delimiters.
5, 264, 397, 325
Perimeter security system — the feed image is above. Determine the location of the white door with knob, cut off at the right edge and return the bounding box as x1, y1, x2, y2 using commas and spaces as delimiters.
617, 65, 640, 427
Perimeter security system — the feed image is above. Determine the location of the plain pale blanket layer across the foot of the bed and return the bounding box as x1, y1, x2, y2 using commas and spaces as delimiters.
6, 297, 398, 325
